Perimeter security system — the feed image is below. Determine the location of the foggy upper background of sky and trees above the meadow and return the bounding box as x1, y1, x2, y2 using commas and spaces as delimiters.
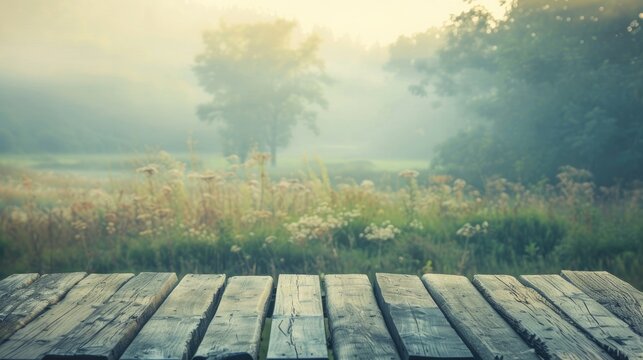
0, 0, 643, 184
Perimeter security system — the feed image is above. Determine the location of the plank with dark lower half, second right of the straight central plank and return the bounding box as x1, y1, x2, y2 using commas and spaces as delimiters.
375, 273, 473, 359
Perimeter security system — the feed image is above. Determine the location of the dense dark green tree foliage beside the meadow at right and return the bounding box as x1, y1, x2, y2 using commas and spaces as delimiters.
389, 0, 643, 183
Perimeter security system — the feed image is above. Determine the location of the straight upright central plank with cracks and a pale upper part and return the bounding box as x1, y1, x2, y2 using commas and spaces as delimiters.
267, 275, 328, 359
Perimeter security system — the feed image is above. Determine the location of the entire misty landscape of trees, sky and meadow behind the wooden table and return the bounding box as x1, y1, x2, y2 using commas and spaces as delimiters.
0, 0, 643, 289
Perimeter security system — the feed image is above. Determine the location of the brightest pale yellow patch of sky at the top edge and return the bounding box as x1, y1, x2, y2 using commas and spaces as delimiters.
196, 0, 503, 45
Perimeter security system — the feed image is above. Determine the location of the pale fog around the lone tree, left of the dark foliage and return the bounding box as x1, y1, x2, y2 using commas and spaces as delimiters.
0, 0, 472, 158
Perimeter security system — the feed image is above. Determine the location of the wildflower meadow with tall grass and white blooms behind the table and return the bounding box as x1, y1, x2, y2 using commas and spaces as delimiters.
0, 152, 643, 288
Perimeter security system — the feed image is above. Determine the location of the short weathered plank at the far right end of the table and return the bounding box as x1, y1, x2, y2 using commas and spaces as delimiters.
561, 270, 643, 335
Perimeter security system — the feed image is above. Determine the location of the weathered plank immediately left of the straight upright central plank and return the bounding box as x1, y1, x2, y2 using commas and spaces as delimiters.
193, 276, 272, 360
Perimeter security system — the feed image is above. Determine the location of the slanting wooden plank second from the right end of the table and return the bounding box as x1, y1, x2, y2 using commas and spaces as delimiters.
520, 275, 643, 360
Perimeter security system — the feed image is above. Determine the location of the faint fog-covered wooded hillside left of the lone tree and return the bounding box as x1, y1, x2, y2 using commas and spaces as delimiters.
0, 78, 218, 153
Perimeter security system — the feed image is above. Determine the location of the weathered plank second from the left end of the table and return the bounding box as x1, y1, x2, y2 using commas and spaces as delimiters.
0, 272, 86, 341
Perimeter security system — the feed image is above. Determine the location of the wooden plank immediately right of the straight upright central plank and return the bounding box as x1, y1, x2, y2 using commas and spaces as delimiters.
324, 275, 399, 360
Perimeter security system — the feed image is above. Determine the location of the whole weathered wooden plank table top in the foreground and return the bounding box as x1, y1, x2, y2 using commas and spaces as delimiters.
0, 271, 643, 360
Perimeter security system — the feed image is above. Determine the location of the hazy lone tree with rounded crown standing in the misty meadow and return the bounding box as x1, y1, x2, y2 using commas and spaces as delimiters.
194, 20, 328, 165
